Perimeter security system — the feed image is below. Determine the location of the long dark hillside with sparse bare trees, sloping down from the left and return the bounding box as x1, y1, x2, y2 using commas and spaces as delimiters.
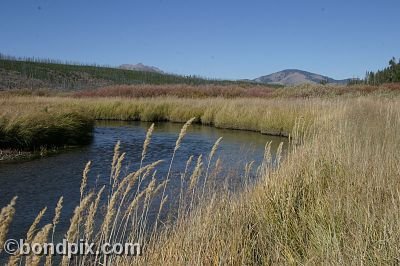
0, 55, 250, 90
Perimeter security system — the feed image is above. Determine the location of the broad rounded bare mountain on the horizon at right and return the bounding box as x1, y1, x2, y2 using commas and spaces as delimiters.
253, 69, 349, 85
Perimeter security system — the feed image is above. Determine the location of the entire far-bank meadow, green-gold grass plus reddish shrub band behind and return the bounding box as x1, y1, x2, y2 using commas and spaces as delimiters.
0, 84, 400, 150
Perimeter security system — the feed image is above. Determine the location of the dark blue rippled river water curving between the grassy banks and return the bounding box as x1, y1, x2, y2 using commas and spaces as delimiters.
0, 122, 286, 242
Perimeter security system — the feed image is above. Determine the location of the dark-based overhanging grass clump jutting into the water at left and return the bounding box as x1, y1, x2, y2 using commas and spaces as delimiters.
0, 99, 94, 151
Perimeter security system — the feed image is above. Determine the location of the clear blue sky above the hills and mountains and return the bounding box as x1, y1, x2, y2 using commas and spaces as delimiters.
0, 0, 400, 79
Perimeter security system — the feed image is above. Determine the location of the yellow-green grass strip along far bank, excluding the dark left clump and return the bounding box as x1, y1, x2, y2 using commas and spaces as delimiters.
0, 96, 322, 135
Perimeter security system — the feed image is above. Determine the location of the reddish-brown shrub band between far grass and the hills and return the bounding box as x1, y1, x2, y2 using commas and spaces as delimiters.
72, 83, 400, 98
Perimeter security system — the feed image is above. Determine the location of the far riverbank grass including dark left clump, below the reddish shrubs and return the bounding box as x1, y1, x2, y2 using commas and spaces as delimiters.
0, 95, 318, 158
